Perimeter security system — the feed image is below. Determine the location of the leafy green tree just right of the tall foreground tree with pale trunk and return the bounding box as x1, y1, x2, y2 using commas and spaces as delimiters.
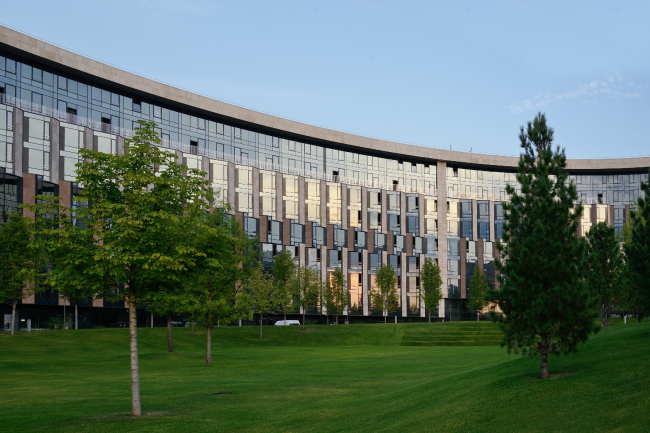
187, 203, 253, 365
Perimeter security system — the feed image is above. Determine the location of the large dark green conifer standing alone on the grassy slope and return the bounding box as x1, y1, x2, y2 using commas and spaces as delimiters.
488, 113, 599, 379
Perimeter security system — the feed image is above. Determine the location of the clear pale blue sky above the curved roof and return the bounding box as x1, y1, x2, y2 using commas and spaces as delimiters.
0, 0, 650, 158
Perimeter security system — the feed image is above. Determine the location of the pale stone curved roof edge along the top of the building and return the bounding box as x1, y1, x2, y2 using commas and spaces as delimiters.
0, 26, 650, 172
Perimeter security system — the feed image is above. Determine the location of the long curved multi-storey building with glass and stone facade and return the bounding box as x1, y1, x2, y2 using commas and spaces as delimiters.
0, 26, 650, 326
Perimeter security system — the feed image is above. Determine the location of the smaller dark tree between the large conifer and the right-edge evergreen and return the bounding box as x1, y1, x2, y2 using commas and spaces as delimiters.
587, 222, 624, 327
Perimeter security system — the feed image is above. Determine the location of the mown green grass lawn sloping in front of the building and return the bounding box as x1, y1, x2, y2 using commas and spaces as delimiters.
0, 323, 650, 432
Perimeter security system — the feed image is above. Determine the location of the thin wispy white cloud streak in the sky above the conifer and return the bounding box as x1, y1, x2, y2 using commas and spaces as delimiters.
508, 74, 642, 114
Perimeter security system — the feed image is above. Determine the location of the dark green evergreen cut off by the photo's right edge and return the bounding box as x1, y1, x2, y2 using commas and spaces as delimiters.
624, 170, 650, 323
